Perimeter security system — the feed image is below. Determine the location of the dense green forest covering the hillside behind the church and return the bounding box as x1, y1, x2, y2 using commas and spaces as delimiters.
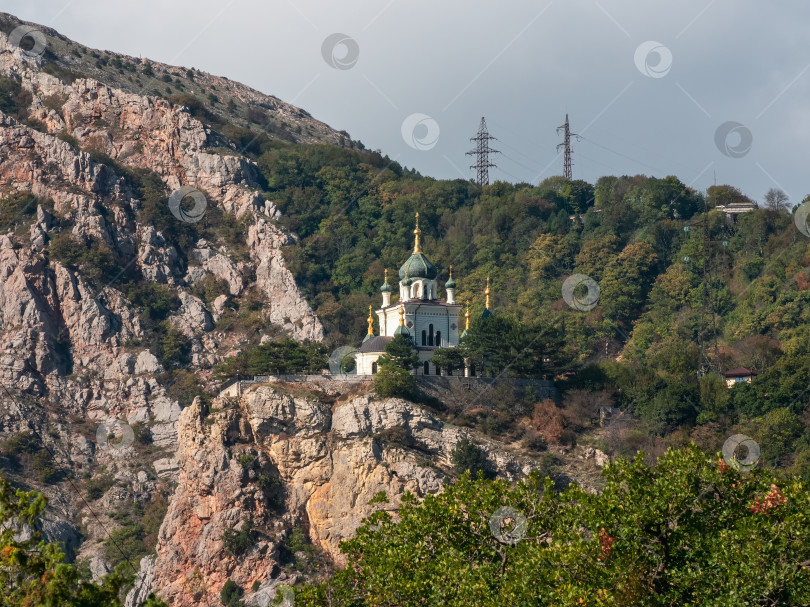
246, 144, 810, 475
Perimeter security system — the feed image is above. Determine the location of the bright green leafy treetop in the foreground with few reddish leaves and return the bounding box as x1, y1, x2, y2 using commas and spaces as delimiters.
296, 446, 810, 607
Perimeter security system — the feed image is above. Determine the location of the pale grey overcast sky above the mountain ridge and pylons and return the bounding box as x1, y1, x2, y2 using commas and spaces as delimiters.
6, 0, 810, 203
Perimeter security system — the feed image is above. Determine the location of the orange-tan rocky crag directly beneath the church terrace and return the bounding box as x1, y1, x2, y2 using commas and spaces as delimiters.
147, 384, 548, 605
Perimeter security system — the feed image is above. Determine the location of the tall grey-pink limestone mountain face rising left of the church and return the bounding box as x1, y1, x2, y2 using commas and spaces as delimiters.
0, 14, 324, 592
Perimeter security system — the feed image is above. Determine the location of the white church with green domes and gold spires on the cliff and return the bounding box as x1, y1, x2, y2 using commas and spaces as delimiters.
355, 213, 469, 375
